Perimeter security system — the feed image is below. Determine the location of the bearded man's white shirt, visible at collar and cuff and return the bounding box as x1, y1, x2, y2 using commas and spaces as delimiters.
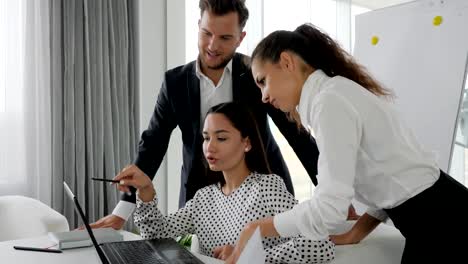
112, 59, 233, 220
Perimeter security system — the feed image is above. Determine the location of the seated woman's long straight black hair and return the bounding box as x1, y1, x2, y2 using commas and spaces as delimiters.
205, 102, 271, 185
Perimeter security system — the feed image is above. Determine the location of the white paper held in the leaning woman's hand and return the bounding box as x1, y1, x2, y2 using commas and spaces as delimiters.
237, 227, 266, 264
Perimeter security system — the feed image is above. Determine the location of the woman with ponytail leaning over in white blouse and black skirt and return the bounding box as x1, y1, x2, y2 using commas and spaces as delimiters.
227, 24, 468, 263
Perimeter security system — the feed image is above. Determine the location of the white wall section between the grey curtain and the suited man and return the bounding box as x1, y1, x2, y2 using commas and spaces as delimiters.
138, 0, 185, 213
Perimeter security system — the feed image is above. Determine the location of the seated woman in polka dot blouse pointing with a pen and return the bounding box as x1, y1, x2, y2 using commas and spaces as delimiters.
115, 103, 335, 263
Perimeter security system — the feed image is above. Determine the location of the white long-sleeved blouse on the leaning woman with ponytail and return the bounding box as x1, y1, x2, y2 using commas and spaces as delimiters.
274, 70, 440, 239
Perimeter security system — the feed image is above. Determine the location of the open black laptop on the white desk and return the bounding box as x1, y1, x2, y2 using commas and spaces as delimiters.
63, 182, 203, 264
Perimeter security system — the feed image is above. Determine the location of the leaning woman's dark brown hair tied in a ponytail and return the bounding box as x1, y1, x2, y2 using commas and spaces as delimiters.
252, 24, 393, 98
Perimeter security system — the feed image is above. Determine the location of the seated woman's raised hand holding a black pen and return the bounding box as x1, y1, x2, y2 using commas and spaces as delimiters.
114, 164, 156, 202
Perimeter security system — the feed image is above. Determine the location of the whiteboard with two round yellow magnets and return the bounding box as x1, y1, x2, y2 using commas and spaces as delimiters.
354, 0, 468, 171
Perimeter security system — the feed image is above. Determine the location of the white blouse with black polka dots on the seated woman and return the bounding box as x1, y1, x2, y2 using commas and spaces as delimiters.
134, 173, 335, 263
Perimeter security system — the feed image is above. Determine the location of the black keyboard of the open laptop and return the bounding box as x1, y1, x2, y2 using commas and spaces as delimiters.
112, 243, 168, 264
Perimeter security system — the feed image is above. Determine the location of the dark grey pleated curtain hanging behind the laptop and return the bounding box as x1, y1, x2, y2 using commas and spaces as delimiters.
50, 0, 139, 228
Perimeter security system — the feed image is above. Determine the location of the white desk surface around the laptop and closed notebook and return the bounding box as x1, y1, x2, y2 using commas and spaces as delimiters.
0, 231, 224, 264
